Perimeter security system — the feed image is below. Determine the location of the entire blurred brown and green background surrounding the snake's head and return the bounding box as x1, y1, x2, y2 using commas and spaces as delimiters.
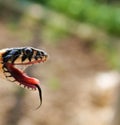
0, 0, 120, 125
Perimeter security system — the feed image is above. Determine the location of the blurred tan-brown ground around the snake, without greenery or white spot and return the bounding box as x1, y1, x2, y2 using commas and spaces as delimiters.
0, 22, 117, 125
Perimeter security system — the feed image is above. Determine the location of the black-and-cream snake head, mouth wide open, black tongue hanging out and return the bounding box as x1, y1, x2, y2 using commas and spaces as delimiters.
2, 47, 48, 108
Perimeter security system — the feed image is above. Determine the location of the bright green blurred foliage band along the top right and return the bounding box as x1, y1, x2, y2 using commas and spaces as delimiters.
27, 0, 120, 35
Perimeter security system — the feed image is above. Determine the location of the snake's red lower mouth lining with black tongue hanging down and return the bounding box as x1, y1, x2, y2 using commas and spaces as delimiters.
5, 63, 42, 109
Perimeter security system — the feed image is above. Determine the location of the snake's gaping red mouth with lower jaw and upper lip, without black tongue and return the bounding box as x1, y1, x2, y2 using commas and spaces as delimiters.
3, 56, 47, 90
